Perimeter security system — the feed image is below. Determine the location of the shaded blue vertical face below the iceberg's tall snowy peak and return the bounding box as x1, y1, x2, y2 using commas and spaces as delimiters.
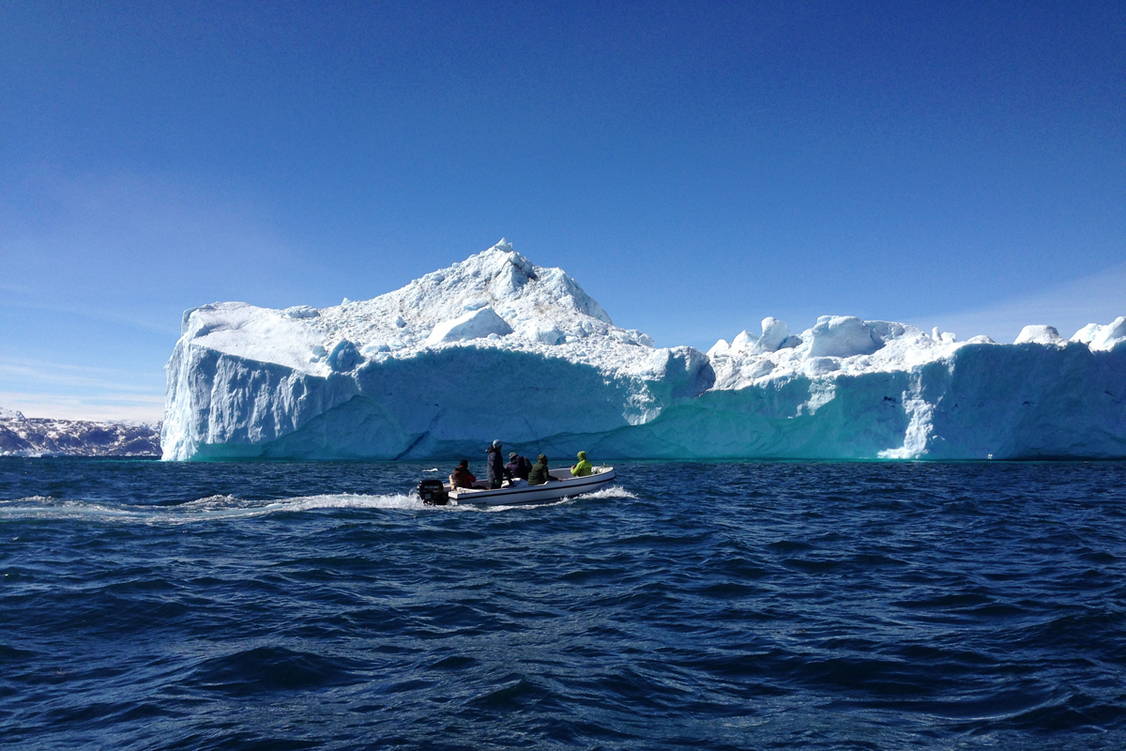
177, 347, 714, 459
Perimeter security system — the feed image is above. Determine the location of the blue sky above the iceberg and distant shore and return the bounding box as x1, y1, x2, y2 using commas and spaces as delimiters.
0, 0, 1126, 417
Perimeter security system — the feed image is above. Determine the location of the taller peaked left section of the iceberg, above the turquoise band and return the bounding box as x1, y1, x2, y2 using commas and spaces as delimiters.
162, 240, 680, 459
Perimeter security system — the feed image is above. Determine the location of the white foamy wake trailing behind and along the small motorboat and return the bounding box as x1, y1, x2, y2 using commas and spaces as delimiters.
0, 485, 636, 525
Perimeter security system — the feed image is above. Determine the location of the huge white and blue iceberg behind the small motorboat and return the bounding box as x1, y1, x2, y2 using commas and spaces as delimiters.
161, 240, 1126, 459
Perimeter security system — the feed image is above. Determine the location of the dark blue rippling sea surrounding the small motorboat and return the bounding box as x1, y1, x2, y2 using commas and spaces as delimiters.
0, 458, 1126, 751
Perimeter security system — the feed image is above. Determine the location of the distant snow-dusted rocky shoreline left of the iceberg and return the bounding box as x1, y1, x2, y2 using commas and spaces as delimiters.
0, 409, 160, 457
